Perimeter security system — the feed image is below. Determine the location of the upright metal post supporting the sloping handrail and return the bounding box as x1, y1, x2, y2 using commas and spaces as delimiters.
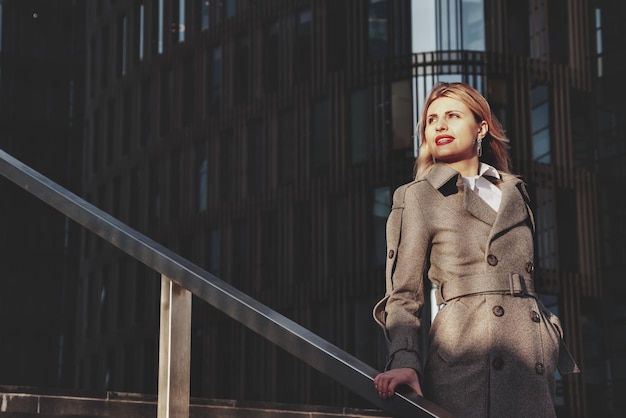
157, 275, 191, 418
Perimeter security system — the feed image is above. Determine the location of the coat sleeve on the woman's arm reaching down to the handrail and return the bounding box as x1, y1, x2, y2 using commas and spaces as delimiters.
374, 185, 430, 374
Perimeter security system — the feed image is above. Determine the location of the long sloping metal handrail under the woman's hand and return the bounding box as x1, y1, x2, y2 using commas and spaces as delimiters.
0, 150, 451, 417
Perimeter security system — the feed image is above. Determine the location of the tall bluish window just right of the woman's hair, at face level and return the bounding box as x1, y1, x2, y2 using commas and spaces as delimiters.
531, 85, 551, 164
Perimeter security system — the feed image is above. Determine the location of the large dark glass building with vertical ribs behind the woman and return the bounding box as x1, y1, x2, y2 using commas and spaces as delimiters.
0, 0, 626, 416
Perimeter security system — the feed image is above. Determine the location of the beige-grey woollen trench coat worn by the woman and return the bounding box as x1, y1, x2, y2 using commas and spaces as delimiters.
374, 164, 578, 417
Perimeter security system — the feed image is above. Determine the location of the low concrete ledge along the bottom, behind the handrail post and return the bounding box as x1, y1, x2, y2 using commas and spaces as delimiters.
0, 386, 388, 418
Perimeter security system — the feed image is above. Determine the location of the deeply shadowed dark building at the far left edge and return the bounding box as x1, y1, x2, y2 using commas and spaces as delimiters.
0, 0, 85, 387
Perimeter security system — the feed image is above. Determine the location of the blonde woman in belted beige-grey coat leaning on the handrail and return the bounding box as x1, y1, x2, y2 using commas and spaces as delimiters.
374, 83, 578, 417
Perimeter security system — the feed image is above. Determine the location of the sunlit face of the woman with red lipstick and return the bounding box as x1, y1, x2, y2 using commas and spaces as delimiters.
424, 97, 487, 164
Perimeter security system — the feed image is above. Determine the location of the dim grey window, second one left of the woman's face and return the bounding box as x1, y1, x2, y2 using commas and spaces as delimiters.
350, 89, 370, 164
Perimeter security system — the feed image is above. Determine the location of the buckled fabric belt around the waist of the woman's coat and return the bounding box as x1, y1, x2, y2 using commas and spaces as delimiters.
436, 273, 537, 305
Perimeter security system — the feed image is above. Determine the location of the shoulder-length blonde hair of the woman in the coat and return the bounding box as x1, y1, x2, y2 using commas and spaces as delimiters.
413, 82, 511, 178
